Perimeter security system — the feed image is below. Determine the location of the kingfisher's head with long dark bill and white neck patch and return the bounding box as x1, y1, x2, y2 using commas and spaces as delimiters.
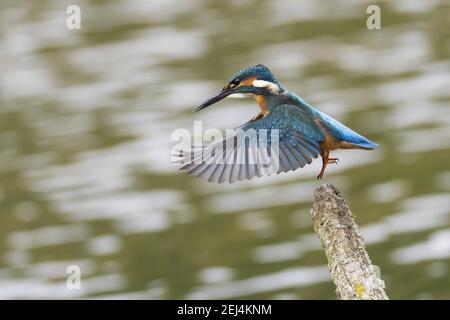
194, 64, 284, 111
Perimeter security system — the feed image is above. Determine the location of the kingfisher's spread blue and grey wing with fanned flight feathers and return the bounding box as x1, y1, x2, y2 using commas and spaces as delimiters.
180, 104, 324, 183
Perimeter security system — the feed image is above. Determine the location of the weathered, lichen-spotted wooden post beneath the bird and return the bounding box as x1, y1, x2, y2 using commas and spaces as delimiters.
311, 184, 389, 300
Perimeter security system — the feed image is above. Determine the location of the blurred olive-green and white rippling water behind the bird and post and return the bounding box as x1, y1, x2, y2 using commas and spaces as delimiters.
0, 0, 450, 299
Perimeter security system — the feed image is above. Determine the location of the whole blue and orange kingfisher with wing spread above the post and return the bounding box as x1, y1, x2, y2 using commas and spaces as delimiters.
180, 64, 378, 183
